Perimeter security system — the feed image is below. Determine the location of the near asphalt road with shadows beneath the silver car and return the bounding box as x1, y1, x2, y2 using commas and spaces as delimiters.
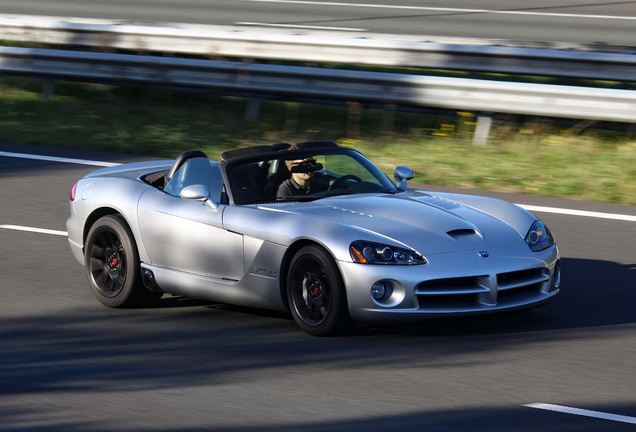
0, 144, 636, 432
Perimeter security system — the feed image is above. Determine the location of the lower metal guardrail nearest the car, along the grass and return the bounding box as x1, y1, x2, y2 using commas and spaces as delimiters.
0, 47, 636, 122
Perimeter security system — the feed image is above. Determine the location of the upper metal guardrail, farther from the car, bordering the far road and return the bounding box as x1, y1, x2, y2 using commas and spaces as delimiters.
0, 15, 636, 81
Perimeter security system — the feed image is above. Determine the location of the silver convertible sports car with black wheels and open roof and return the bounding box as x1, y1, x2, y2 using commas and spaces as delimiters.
67, 142, 561, 335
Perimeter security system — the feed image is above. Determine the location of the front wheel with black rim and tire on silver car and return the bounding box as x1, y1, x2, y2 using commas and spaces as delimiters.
287, 245, 352, 336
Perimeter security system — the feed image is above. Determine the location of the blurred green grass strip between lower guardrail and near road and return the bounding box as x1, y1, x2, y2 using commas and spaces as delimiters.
0, 77, 636, 205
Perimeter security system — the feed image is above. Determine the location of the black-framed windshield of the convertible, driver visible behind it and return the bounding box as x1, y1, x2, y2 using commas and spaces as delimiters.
227, 151, 397, 204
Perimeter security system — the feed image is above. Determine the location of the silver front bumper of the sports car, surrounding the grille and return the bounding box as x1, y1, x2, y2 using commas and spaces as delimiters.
338, 244, 561, 323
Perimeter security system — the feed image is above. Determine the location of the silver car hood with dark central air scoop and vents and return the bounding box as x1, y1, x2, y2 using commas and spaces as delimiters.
260, 192, 530, 255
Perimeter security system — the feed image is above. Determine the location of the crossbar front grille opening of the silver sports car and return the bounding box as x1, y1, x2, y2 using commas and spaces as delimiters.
415, 268, 550, 312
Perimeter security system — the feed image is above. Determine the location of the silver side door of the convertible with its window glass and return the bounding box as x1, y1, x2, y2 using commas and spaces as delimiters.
137, 158, 245, 281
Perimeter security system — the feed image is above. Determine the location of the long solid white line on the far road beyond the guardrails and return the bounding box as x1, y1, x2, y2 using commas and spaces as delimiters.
243, 0, 636, 21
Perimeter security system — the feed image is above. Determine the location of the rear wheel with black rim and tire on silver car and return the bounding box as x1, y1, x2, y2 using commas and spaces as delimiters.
84, 215, 161, 308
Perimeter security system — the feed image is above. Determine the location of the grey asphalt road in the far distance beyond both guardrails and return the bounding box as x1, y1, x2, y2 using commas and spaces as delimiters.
0, 0, 636, 46
